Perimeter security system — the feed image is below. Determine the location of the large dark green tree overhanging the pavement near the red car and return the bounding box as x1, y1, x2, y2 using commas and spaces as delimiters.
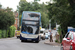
47, 0, 75, 41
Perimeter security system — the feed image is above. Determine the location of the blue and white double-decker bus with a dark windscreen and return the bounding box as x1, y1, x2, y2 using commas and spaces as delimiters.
20, 11, 41, 43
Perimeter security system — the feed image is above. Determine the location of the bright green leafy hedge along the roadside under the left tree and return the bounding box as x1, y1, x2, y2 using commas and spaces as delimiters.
0, 26, 16, 38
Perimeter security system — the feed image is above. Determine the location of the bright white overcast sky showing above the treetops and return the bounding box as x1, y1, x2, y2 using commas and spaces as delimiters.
0, 0, 50, 11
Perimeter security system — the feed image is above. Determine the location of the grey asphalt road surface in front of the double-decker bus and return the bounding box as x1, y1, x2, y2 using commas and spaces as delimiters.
0, 37, 60, 50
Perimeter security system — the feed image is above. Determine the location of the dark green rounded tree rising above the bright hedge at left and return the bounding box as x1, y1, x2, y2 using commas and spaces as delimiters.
0, 8, 15, 29
